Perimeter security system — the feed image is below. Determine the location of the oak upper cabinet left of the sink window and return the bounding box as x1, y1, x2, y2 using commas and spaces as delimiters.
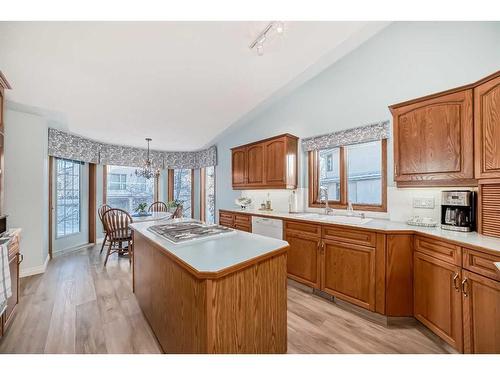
231, 134, 298, 189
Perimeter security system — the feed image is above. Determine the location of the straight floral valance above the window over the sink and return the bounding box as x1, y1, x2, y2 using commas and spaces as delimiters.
302, 120, 390, 151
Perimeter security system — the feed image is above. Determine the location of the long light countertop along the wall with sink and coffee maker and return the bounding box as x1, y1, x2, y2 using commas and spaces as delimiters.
220, 208, 500, 253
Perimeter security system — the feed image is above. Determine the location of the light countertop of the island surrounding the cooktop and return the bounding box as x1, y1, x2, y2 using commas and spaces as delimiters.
130, 219, 288, 273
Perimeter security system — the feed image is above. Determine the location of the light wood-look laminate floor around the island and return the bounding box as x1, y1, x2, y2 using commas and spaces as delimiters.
0, 246, 454, 353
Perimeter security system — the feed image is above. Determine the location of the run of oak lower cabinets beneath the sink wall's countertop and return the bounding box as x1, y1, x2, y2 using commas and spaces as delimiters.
220, 213, 500, 354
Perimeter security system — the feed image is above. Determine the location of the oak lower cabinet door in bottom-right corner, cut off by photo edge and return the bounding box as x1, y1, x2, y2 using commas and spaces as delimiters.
462, 271, 500, 354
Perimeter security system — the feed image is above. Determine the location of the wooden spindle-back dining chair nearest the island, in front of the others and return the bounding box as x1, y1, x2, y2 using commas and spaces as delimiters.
102, 208, 134, 266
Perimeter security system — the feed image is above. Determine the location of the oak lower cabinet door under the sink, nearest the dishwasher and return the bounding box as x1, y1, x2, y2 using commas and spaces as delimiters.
285, 231, 321, 288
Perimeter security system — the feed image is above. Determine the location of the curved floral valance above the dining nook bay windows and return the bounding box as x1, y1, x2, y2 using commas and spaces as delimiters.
49, 128, 217, 169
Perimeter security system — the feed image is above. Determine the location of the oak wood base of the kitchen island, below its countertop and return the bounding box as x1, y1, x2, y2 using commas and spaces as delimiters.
133, 231, 287, 353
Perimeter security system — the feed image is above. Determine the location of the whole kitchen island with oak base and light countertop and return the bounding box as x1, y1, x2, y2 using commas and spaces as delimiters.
131, 222, 288, 353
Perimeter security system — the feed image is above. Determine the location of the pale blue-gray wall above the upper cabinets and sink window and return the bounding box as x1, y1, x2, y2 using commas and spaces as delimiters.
216, 22, 500, 213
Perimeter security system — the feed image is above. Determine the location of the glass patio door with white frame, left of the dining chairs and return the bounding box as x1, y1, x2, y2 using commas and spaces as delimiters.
51, 158, 89, 253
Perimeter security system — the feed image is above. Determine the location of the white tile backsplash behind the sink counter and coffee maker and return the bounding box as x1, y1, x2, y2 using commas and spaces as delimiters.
235, 186, 476, 222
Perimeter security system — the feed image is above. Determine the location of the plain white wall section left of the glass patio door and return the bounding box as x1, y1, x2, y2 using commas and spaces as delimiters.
5, 107, 49, 276
